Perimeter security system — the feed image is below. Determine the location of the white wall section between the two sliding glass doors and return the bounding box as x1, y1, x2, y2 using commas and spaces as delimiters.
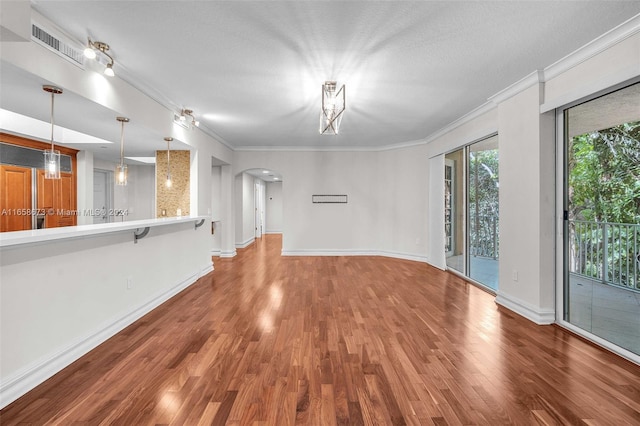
497, 84, 555, 324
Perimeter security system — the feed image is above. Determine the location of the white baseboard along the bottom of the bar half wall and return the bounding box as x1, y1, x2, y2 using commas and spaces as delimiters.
0, 270, 202, 409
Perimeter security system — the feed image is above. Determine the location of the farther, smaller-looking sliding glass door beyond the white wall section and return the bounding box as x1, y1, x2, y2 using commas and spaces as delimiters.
445, 136, 499, 290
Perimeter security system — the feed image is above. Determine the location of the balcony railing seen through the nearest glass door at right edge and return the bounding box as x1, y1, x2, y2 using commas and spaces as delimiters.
569, 220, 640, 291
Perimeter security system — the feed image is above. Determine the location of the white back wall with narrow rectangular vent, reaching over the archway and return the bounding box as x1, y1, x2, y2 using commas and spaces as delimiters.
234, 150, 427, 260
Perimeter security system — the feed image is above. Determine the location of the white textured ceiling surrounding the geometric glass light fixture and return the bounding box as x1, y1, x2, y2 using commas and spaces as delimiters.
3, 1, 640, 155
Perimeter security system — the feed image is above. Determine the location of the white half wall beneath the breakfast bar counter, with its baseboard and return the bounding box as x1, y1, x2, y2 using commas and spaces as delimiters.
0, 221, 212, 407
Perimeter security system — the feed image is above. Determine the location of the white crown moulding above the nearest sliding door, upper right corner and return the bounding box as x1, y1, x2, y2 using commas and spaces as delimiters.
543, 14, 640, 81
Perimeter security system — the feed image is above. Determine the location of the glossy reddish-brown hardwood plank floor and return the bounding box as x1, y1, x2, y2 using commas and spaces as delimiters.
0, 235, 640, 425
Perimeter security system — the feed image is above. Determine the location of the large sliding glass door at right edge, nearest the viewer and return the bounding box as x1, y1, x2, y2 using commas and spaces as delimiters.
563, 83, 640, 355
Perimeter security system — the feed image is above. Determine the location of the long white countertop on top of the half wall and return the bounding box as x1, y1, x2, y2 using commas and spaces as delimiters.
0, 216, 209, 247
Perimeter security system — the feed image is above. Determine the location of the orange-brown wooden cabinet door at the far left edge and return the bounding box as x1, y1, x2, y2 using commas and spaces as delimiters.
0, 165, 32, 232
